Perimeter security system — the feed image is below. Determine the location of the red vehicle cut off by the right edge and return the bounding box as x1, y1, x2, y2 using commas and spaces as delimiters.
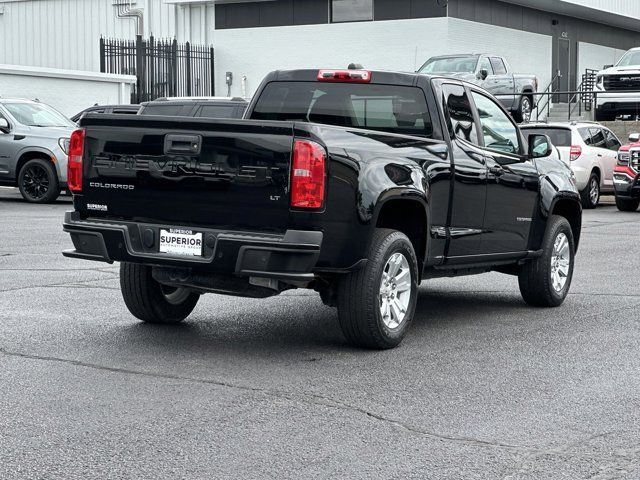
613, 133, 640, 212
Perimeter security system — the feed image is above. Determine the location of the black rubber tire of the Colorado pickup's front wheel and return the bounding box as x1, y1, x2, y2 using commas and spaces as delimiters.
518, 215, 575, 307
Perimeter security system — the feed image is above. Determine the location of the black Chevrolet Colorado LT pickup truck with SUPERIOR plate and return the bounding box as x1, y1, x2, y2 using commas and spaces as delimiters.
64, 70, 582, 348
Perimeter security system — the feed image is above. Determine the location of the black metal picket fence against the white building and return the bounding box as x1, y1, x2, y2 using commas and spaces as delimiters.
100, 36, 215, 103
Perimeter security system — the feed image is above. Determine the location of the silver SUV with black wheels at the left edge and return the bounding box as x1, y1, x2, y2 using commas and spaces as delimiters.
0, 98, 76, 203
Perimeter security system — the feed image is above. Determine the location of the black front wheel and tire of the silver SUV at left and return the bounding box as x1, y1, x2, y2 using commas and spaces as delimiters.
18, 158, 60, 203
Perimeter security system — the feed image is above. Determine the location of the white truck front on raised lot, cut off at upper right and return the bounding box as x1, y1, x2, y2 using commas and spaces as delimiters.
594, 47, 640, 122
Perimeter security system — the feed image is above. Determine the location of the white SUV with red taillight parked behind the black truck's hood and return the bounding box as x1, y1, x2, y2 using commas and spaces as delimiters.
522, 122, 620, 208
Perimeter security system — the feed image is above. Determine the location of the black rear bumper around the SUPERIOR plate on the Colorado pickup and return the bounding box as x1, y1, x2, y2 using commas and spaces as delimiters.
63, 212, 323, 281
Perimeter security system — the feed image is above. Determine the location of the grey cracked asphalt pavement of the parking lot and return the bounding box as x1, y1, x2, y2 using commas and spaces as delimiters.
0, 188, 640, 480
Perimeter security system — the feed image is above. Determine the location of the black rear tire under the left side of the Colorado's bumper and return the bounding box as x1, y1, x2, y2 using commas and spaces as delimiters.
120, 263, 200, 324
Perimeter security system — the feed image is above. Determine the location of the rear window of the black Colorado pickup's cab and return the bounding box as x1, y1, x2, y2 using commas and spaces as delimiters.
251, 82, 433, 137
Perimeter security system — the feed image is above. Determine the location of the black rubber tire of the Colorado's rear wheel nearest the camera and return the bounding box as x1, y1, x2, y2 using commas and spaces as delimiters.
337, 228, 418, 349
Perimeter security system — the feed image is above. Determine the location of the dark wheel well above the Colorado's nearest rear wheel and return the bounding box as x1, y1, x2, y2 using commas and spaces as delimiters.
376, 200, 427, 272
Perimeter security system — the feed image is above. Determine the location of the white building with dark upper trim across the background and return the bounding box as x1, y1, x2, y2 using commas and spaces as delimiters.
0, 0, 640, 100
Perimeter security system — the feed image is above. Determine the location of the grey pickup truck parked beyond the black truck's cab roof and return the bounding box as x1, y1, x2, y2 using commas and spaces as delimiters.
418, 54, 538, 123
